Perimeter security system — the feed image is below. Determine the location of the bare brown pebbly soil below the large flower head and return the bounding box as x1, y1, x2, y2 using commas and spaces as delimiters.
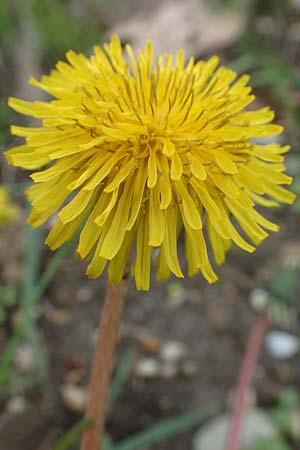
0, 206, 300, 450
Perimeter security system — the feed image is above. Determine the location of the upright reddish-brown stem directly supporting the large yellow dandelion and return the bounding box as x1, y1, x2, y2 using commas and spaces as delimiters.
81, 284, 124, 450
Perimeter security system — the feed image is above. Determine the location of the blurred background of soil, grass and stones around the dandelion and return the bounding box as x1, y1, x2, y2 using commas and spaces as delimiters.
0, 0, 300, 450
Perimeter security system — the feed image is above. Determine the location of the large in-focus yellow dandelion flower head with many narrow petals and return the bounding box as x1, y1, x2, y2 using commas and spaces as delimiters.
6, 36, 294, 290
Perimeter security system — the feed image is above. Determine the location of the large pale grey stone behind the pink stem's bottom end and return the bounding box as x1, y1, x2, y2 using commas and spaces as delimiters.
193, 408, 278, 450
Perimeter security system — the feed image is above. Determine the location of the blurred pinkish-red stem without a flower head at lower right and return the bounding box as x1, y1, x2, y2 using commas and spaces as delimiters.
226, 315, 268, 450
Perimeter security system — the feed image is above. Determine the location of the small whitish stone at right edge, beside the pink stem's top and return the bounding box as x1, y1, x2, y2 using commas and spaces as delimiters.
265, 331, 300, 359
